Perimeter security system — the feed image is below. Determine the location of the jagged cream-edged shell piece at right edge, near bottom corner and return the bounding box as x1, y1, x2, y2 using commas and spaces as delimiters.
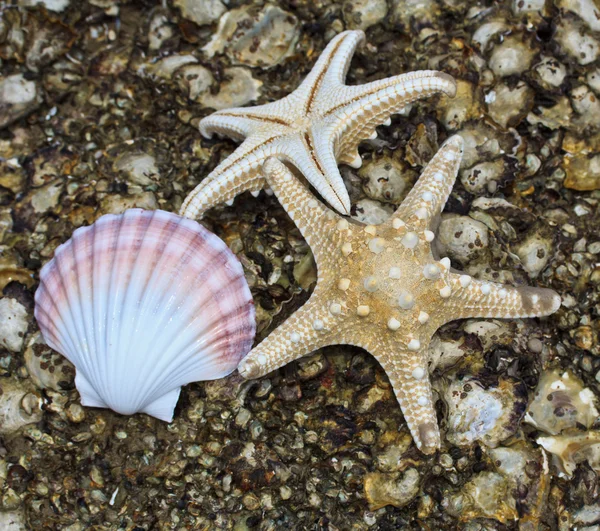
536, 431, 600, 477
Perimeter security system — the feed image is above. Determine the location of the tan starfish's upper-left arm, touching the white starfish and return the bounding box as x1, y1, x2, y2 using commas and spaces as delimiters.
263, 157, 342, 256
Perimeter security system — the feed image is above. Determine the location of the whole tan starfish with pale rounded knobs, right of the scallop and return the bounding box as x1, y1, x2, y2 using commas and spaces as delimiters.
238, 136, 560, 453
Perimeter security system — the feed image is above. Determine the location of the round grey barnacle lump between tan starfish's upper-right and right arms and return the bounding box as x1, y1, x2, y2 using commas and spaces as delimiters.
434, 214, 489, 263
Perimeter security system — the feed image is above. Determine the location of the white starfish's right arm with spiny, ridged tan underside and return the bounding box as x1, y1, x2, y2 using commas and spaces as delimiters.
332, 70, 456, 164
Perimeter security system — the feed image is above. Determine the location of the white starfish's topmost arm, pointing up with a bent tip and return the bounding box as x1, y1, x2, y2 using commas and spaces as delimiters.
296, 30, 365, 109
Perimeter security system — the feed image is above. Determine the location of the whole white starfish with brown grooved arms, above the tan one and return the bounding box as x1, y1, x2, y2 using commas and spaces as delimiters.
180, 31, 456, 218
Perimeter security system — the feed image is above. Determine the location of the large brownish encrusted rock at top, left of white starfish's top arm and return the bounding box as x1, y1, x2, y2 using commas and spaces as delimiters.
203, 5, 298, 67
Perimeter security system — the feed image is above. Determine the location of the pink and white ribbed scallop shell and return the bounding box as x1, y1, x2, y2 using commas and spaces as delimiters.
35, 209, 256, 422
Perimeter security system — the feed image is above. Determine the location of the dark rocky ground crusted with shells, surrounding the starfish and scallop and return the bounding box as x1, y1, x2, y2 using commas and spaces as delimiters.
0, 0, 600, 531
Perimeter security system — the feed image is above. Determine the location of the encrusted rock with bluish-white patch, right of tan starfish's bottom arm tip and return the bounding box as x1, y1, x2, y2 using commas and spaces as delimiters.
442, 376, 527, 448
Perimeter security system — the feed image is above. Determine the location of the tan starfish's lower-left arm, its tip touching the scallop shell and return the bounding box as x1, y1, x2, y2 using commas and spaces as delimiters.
238, 296, 335, 380
